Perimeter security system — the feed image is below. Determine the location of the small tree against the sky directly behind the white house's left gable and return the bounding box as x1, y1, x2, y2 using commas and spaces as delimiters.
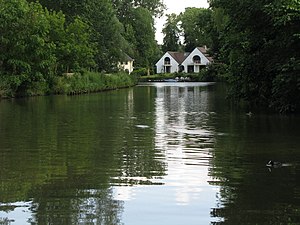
162, 13, 180, 52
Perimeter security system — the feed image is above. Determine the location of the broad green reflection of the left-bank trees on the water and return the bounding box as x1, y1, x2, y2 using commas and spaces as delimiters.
0, 86, 165, 224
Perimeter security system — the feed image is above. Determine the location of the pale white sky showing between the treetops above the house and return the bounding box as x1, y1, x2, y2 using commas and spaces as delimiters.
155, 0, 209, 44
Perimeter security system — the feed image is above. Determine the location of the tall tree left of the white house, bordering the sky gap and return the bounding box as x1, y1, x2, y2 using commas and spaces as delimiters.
113, 0, 165, 68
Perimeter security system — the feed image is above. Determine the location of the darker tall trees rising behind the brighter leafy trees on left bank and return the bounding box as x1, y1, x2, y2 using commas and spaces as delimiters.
30, 0, 165, 71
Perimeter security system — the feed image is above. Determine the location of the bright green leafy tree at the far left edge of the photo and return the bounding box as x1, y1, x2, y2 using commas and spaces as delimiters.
0, 0, 55, 94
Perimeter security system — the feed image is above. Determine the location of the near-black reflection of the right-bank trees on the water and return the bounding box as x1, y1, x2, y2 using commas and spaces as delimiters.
210, 110, 300, 224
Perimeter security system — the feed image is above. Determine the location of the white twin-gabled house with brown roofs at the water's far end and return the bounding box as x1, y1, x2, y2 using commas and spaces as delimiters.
155, 47, 212, 73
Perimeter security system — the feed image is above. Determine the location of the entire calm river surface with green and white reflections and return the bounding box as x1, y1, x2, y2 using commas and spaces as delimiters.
0, 83, 300, 225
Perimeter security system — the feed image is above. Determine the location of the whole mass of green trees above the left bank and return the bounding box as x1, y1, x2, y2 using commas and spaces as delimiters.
0, 0, 164, 95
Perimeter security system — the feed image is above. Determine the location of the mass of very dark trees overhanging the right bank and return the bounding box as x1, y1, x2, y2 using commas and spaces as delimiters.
210, 0, 300, 112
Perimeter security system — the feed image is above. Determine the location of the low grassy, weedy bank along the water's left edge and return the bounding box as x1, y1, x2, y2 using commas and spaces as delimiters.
0, 71, 137, 98
